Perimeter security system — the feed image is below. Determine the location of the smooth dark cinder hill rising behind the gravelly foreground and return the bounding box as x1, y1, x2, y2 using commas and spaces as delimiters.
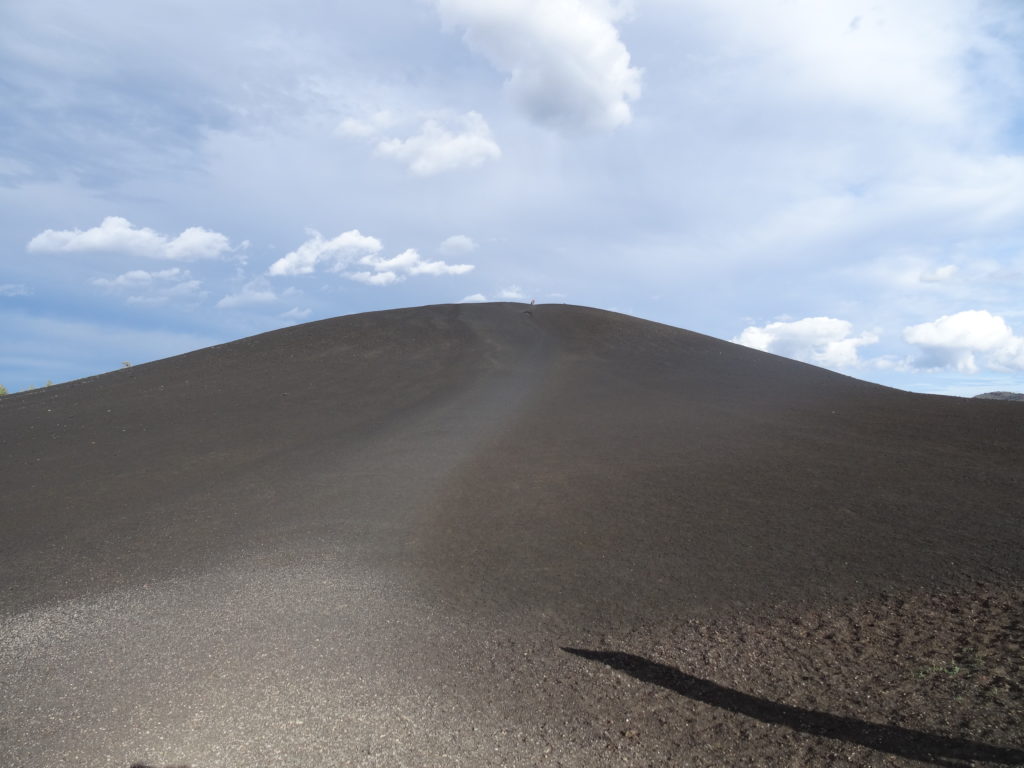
0, 304, 1024, 609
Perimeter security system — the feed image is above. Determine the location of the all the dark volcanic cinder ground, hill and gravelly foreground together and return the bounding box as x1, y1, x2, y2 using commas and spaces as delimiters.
0, 303, 1024, 768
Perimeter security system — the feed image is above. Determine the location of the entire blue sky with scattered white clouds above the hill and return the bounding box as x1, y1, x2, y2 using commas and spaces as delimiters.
0, 0, 1024, 395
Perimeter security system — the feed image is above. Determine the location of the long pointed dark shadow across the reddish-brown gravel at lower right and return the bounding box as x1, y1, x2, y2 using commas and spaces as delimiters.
562, 648, 1024, 766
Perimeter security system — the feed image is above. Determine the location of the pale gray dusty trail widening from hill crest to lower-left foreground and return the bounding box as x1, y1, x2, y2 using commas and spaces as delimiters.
0, 311, 569, 766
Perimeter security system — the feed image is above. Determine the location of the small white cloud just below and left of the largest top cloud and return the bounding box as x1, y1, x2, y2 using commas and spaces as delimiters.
377, 112, 502, 176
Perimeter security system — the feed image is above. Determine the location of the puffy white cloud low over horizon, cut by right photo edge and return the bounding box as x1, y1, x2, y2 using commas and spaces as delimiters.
903, 309, 1024, 374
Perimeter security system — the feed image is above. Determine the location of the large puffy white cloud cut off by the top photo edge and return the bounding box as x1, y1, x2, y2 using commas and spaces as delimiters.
435, 0, 642, 129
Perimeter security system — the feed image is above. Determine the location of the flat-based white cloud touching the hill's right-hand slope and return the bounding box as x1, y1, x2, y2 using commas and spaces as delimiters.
733, 317, 879, 368
